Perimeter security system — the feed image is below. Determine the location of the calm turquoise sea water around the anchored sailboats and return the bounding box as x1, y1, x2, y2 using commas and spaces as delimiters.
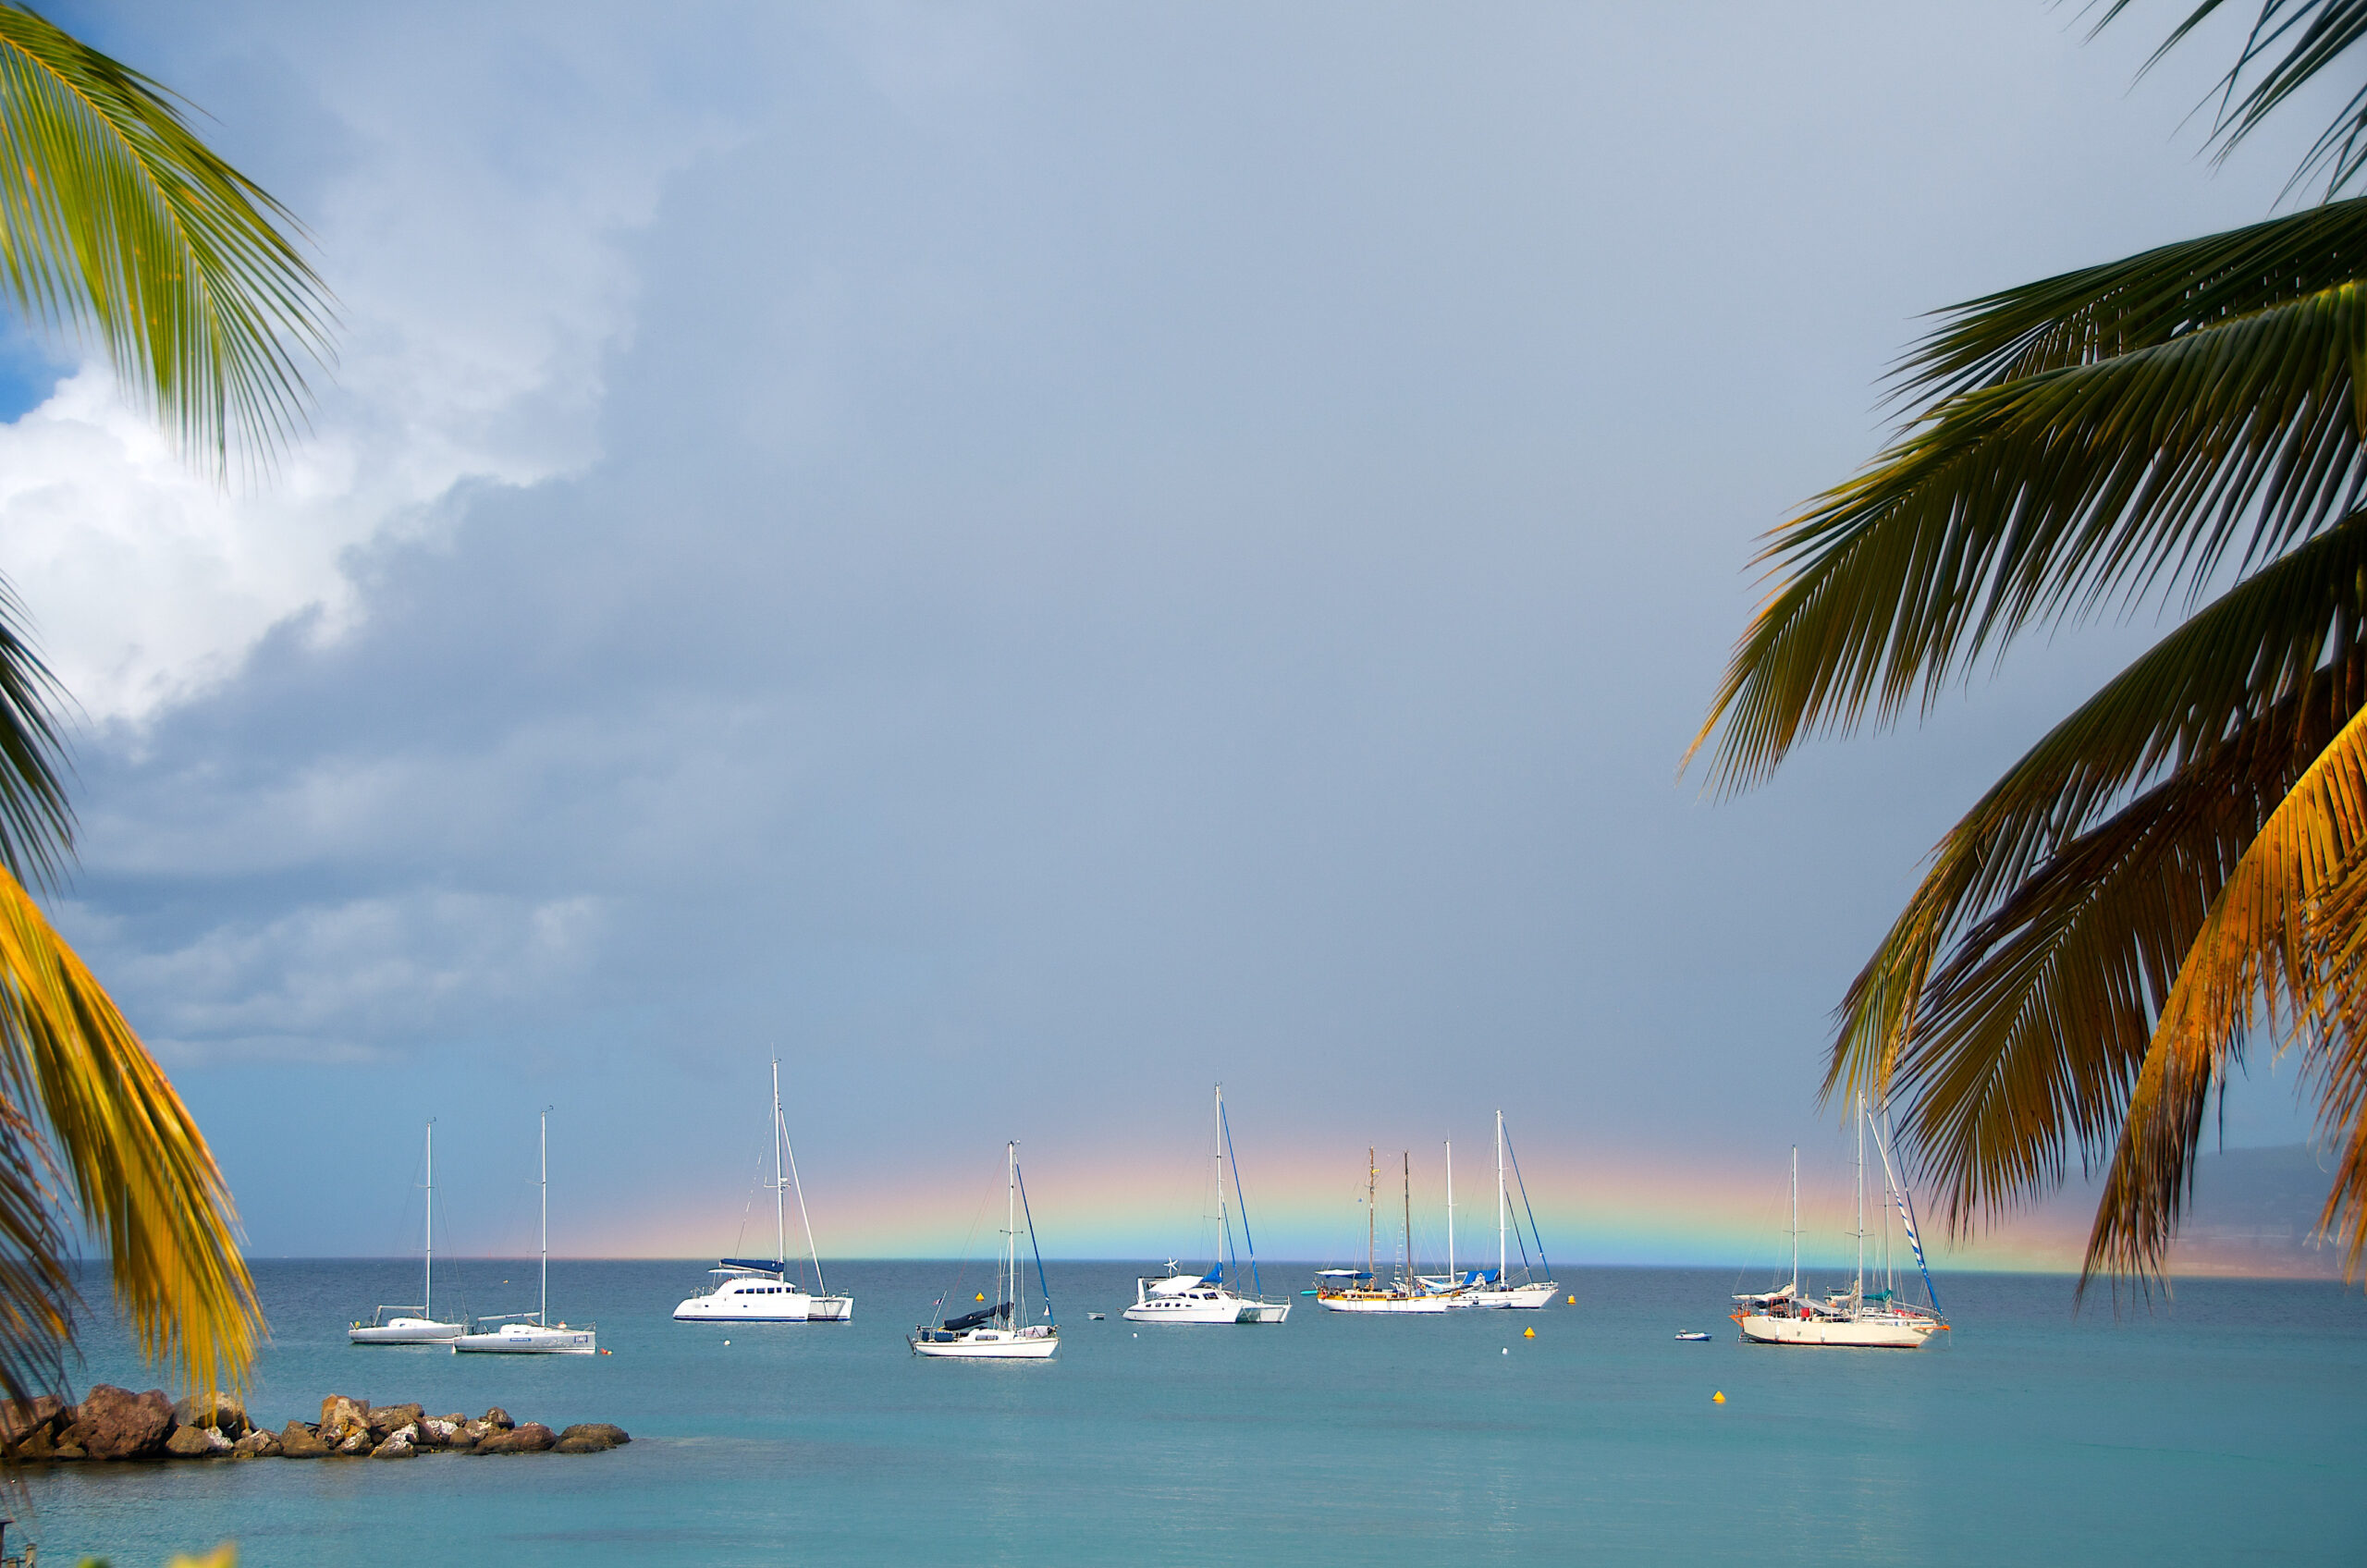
9, 1260, 2367, 1568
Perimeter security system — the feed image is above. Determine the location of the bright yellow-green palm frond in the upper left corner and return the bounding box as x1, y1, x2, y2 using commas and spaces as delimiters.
0, 5, 331, 473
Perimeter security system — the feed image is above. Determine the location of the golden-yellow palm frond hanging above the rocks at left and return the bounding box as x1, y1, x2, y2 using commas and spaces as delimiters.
0, 874, 263, 1390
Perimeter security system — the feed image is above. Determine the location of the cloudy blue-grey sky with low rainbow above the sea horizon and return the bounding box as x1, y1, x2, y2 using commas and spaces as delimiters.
0, 0, 2326, 1263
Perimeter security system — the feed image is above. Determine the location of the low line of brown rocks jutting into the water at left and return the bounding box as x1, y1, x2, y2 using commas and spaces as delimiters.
0, 1383, 632, 1464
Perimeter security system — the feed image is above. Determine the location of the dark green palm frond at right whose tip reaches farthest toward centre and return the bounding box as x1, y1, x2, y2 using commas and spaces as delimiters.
1687, 284, 2367, 789
